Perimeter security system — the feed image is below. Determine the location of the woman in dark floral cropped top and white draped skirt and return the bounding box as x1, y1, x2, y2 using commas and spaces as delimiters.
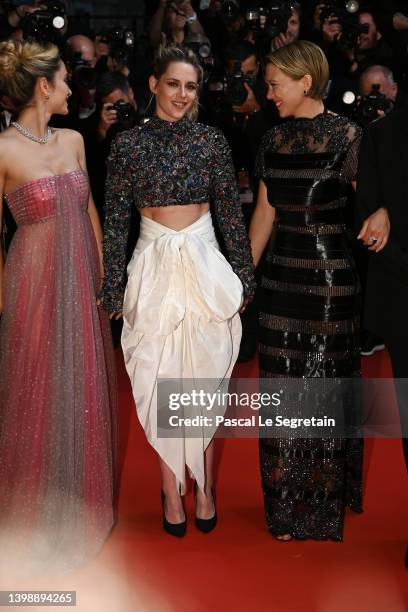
101, 47, 255, 536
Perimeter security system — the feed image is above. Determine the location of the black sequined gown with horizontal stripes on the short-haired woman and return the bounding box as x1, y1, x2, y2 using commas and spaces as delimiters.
257, 112, 362, 540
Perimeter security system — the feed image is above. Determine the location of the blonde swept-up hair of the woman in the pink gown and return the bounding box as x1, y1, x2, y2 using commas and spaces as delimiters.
0, 40, 61, 112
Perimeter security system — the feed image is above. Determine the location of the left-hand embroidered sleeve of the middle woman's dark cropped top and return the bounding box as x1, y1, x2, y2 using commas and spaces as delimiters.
100, 132, 133, 312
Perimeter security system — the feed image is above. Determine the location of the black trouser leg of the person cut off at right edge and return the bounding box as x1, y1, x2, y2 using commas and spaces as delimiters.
385, 336, 408, 470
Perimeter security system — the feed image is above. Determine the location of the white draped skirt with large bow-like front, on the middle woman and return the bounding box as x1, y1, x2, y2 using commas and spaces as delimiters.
122, 212, 243, 493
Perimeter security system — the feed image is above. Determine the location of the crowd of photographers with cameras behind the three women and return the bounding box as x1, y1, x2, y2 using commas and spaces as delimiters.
0, 0, 408, 359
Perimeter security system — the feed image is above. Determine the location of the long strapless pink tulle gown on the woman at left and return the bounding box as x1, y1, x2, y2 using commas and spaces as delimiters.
0, 170, 116, 569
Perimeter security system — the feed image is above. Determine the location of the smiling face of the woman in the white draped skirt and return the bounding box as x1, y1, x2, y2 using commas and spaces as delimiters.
149, 62, 198, 121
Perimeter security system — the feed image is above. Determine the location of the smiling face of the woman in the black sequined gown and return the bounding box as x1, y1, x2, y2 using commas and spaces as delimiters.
265, 64, 311, 117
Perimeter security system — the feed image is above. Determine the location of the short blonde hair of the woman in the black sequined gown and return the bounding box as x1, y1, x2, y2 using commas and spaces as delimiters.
266, 40, 329, 100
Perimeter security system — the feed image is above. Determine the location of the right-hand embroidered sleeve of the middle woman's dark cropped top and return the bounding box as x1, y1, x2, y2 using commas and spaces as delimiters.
211, 130, 256, 298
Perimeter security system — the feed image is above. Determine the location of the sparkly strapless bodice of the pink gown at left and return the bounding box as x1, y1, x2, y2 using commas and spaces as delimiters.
6, 170, 89, 225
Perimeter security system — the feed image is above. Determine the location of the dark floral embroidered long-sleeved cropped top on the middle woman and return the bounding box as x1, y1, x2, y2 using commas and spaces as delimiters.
101, 117, 255, 312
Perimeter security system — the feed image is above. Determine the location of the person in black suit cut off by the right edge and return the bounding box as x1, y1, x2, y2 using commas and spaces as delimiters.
357, 109, 408, 563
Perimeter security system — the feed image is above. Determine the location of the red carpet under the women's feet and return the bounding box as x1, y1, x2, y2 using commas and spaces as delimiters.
81, 352, 408, 612
